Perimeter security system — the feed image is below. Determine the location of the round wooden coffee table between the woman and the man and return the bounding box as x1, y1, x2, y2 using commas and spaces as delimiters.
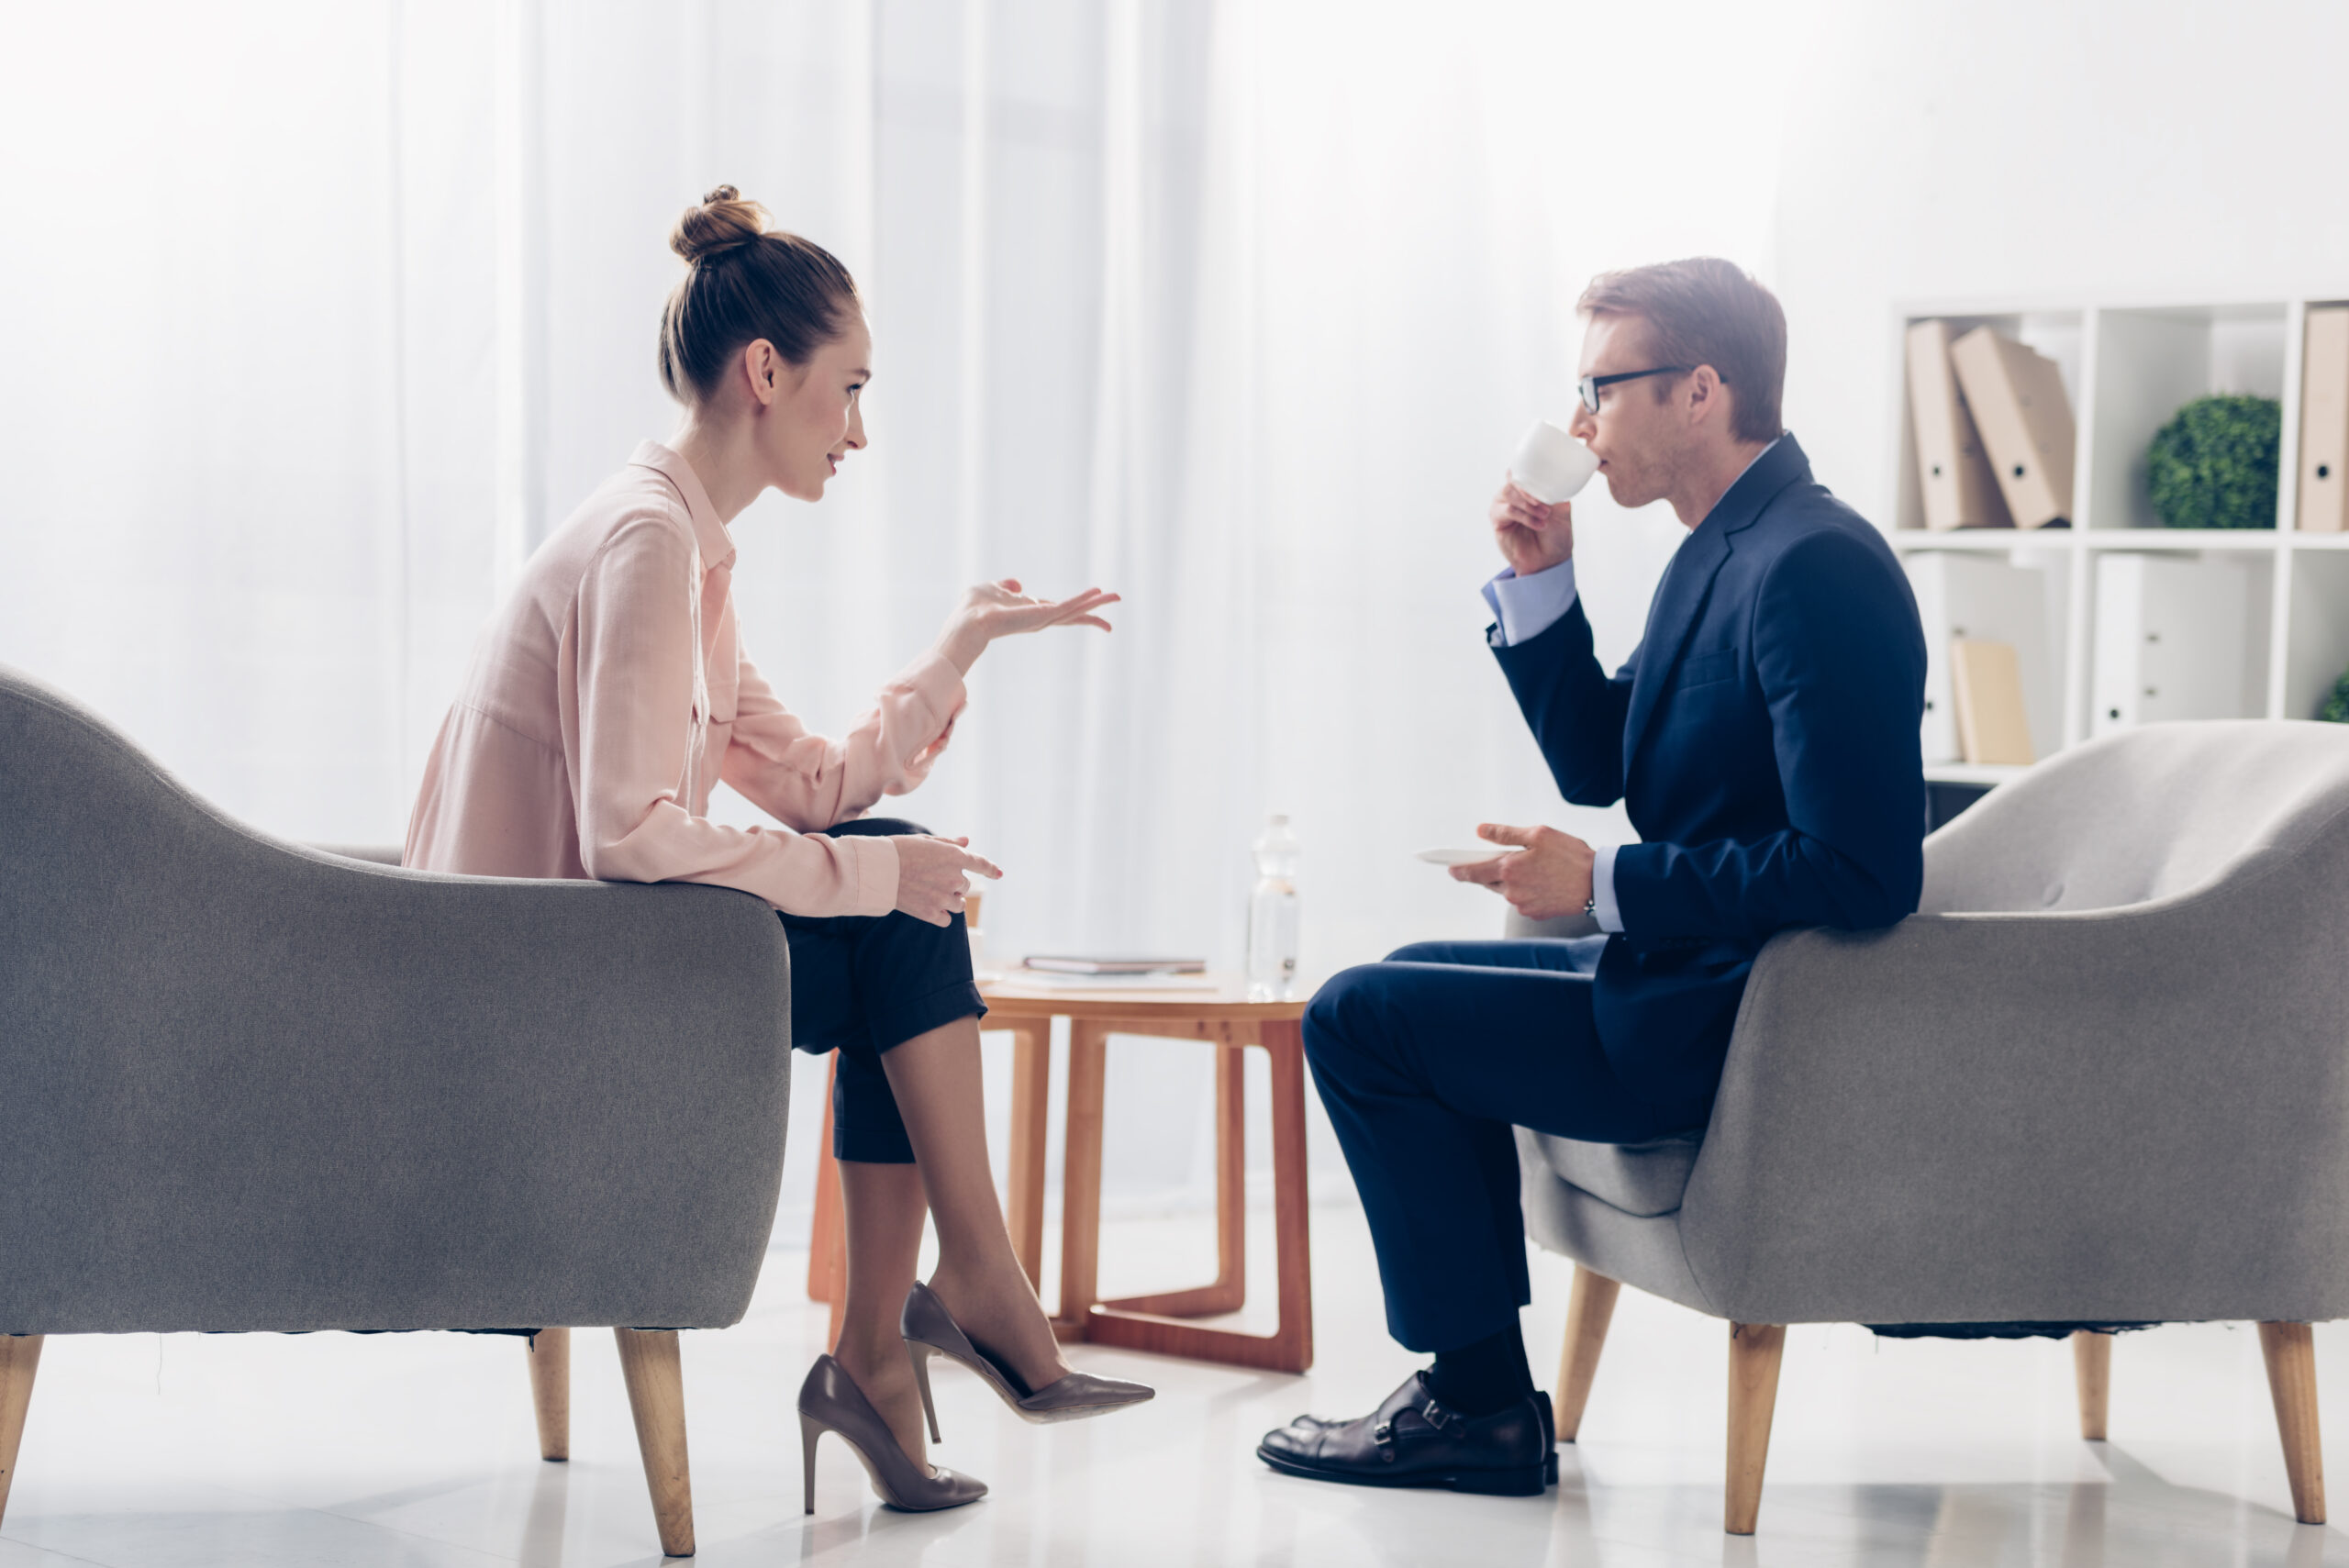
808, 976, 1313, 1373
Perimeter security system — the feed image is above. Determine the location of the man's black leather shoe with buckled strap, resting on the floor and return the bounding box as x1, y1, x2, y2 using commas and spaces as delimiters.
1257, 1371, 1553, 1497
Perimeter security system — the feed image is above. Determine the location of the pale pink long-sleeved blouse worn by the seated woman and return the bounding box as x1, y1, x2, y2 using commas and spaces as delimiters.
402, 441, 965, 916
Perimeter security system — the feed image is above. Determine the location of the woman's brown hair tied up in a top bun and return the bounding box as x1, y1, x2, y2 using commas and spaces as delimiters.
660, 185, 857, 404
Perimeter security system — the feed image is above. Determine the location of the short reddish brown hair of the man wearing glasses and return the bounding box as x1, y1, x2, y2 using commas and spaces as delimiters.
1574, 256, 1786, 441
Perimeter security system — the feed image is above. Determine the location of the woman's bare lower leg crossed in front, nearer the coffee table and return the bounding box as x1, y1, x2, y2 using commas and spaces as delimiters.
883, 1017, 1069, 1390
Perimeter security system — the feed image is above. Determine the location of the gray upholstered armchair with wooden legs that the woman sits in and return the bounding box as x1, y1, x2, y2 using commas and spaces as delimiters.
0, 669, 792, 1551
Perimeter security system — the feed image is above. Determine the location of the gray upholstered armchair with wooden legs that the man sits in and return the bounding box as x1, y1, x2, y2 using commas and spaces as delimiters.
1518, 720, 2349, 1533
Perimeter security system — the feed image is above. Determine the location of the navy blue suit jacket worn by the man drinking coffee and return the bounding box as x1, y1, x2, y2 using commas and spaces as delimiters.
1494, 437, 1926, 1124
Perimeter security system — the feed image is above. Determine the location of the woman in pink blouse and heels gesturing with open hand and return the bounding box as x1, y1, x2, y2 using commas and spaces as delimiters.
406, 185, 1151, 1512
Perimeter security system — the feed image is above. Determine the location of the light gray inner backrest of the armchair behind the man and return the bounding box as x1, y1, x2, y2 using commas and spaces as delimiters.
1921, 718, 2349, 916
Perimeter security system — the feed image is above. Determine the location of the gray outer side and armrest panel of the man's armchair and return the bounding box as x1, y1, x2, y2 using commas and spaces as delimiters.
1682, 845, 2349, 1324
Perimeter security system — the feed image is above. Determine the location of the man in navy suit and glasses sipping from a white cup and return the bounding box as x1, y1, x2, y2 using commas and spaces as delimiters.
1257, 261, 1926, 1496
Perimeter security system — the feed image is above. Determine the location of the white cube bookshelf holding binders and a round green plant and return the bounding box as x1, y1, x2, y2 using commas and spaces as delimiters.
1884, 295, 2349, 784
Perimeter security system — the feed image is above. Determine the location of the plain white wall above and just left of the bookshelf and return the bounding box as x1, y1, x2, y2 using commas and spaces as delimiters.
1776, 0, 2349, 524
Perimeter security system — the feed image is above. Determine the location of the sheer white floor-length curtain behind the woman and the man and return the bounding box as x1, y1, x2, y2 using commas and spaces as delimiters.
0, 0, 1785, 1204
